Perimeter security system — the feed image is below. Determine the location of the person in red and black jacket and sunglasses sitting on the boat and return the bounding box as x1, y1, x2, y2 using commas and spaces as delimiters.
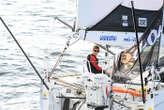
87, 45, 110, 75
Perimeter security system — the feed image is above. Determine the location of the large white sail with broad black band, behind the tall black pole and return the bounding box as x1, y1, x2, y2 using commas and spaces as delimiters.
78, 0, 163, 46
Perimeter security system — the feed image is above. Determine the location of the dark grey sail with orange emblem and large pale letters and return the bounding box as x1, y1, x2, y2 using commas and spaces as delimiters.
113, 8, 163, 78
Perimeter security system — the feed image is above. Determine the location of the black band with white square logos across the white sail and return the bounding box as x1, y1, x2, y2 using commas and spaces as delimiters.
88, 5, 161, 32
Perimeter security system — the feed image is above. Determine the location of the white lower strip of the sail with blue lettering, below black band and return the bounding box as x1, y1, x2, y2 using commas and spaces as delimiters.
80, 30, 142, 48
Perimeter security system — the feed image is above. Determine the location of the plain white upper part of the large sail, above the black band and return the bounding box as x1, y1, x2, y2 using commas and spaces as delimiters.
78, 0, 163, 27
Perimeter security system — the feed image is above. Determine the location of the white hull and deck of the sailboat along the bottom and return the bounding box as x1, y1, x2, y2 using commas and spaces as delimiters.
40, 72, 164, 110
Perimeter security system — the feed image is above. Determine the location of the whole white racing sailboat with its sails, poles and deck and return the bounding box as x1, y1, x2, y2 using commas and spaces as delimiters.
0, 0, 164, 110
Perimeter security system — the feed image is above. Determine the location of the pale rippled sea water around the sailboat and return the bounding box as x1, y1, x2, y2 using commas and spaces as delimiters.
0, 0, 163, 110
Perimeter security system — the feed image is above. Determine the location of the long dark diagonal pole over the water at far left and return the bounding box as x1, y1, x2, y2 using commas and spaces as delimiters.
0, 17, 49, 90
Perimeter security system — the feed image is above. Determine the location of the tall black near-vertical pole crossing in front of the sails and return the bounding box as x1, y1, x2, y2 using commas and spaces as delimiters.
131, 1, 145, 103
